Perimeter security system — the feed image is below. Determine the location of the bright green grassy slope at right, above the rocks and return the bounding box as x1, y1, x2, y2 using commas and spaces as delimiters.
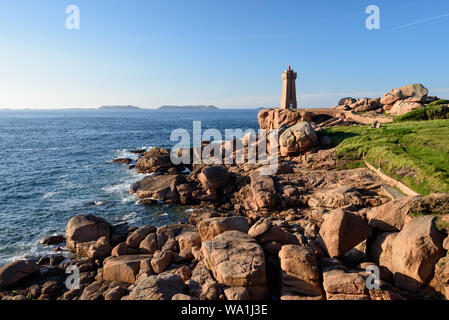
320, 120, 449, 194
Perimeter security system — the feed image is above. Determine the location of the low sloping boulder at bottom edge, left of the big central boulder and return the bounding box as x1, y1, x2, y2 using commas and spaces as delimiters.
126, 273, 186, 300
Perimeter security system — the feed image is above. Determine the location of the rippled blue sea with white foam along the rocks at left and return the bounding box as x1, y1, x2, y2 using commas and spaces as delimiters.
0, 110, 258, 266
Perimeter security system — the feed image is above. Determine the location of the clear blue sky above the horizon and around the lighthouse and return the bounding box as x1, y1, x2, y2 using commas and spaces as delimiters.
0, 0, 449, 108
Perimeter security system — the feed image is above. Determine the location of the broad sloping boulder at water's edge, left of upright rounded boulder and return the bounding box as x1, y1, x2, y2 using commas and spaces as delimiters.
136, 174, 187, 203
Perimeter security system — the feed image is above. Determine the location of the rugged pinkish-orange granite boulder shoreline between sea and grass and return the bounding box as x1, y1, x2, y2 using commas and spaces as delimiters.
0, 88, 449, 300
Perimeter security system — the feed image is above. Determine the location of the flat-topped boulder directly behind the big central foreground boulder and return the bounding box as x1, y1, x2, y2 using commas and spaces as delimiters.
197, 217, 249, 242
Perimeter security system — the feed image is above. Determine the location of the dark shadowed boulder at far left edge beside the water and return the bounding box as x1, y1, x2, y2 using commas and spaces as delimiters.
0, 260, 40, 289
